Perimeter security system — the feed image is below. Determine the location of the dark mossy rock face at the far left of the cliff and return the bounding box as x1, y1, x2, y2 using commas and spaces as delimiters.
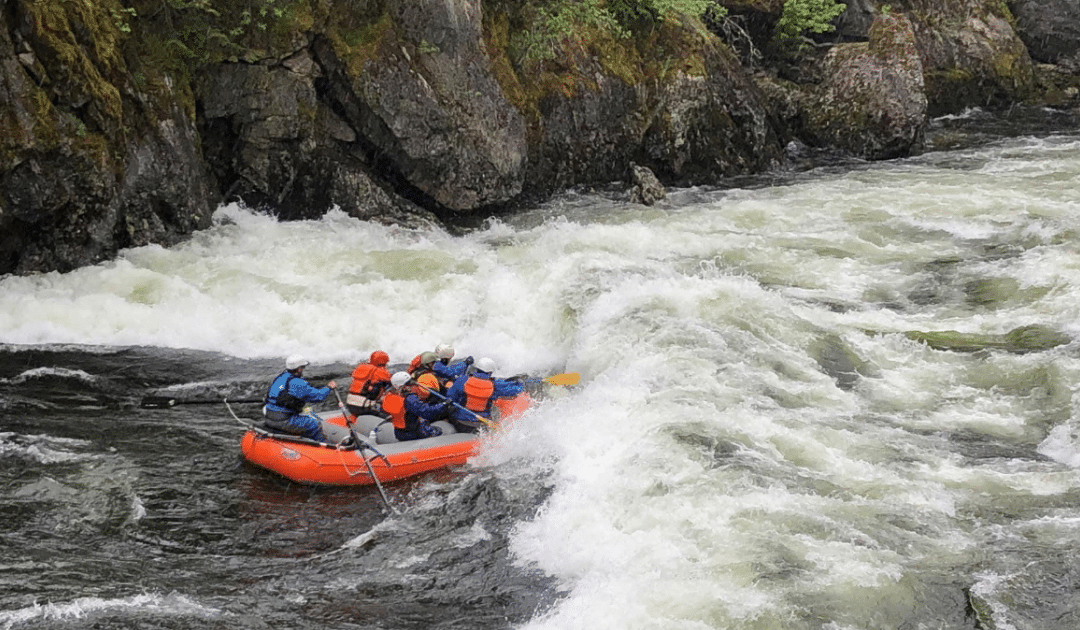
0, 2, 214, 274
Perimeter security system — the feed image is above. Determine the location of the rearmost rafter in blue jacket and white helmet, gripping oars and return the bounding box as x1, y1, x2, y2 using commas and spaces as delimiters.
262, 354, 337, 442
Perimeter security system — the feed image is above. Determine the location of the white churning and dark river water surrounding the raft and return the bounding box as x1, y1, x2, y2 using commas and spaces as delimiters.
0, 109, 1080, 630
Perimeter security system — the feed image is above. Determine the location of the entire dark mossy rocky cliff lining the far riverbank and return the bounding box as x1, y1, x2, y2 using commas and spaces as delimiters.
0, 0, 1080, 273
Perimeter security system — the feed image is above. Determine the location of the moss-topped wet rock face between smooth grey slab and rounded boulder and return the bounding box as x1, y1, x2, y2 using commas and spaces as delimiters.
527, 19, 783, 190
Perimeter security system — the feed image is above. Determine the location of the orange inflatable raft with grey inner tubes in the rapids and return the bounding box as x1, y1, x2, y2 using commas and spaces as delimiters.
240, 392, 531, 485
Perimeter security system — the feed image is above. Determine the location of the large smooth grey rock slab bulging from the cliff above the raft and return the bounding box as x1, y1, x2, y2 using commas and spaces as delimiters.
336, 0, 527, 211
